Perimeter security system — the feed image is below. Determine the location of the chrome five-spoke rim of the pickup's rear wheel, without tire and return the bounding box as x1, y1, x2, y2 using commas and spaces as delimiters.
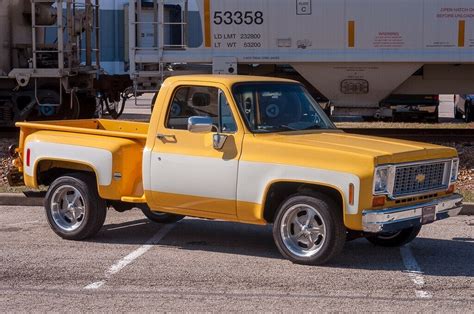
50, 185, 86, 232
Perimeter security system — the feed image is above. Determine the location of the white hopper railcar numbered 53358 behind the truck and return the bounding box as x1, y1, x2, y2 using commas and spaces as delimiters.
126, 0, 474, 115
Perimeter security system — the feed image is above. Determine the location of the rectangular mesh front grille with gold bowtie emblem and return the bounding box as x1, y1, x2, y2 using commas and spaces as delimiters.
393, 161, 450, 196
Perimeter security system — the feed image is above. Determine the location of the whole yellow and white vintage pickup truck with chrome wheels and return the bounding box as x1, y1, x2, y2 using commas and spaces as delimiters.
9, 75, 462, 264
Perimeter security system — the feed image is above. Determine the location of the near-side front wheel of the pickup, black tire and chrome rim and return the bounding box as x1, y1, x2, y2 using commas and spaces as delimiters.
273, 192, 346, 265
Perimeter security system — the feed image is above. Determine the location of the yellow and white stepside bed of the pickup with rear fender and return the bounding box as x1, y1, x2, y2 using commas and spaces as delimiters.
16, 119, 149, 200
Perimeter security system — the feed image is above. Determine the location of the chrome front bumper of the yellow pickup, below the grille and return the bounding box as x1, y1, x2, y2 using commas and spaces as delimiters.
362, 194, 462, 233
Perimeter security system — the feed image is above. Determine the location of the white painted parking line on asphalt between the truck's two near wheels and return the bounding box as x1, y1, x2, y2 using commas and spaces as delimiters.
84, 224, 175, 290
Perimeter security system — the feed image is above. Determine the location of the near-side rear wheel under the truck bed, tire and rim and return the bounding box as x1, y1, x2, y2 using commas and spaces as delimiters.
44, 173, 107, 240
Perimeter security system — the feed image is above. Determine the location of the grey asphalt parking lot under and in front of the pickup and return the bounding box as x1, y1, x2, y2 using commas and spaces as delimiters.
0, 206, 474, 312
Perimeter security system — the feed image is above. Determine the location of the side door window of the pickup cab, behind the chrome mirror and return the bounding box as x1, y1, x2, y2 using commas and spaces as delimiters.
166, 86, 237, 133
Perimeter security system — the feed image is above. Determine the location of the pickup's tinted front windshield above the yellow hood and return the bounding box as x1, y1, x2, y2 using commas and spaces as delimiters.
233, 83, 335, 132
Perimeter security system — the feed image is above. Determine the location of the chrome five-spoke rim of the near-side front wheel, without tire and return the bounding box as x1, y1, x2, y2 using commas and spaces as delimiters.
280, 204, 326, 257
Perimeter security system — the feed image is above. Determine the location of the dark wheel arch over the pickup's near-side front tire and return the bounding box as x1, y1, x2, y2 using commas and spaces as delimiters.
262, 180, 346, 223
